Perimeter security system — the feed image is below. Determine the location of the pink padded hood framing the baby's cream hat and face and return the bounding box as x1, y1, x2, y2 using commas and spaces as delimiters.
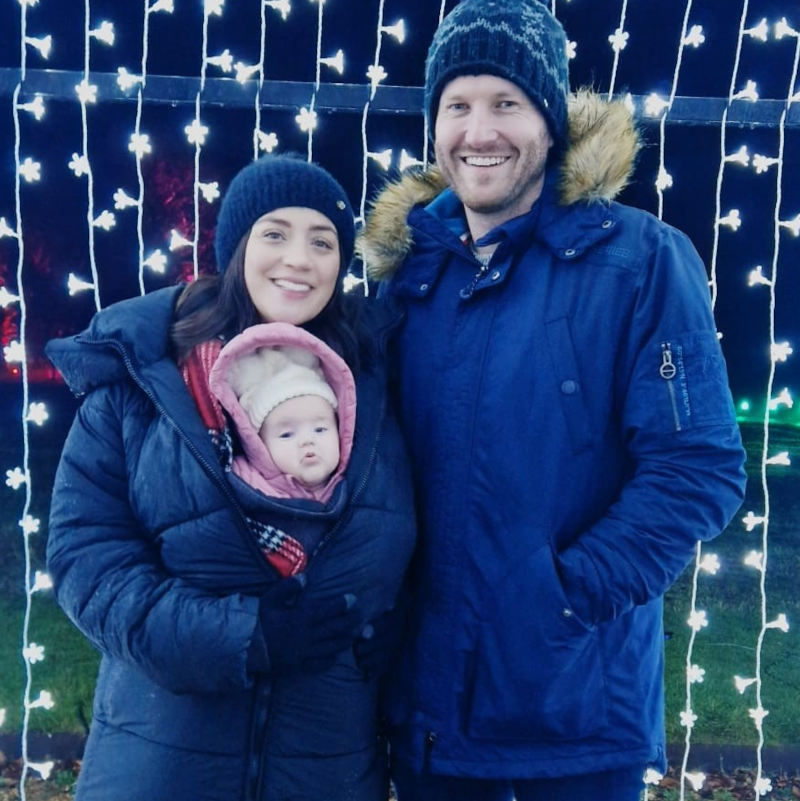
209, 323, 356, 503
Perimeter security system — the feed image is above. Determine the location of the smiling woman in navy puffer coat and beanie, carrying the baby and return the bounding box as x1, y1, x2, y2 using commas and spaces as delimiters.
47, 156, 414, 801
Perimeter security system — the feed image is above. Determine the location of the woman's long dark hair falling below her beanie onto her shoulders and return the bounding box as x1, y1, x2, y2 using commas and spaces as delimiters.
170, 231, 372, 372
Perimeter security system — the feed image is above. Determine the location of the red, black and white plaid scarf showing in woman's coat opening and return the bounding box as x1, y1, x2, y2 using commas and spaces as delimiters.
181, 340, 308, 578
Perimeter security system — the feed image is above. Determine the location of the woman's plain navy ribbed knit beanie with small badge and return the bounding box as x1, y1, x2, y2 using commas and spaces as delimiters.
214, 155, 355, 273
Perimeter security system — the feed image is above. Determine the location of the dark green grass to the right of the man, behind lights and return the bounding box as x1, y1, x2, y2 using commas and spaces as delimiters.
664, 427, 800, 745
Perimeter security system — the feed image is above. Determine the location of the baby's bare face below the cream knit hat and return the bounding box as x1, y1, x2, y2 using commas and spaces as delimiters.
259, 395, 339, 489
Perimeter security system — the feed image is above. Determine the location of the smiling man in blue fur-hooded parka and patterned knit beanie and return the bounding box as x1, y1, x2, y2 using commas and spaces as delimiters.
362, 0, 744, 801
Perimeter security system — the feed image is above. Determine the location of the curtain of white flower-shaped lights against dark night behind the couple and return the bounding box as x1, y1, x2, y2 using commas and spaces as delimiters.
0, 0, 800, 799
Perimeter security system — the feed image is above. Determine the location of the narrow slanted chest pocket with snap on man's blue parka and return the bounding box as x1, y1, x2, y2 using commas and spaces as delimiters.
546, 317, 592, 453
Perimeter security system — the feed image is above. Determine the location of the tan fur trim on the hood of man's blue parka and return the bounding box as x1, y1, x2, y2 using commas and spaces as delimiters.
356, 90, 640, 281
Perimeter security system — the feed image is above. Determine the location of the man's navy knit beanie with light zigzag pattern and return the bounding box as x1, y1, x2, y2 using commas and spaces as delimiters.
425, 0, 569, 147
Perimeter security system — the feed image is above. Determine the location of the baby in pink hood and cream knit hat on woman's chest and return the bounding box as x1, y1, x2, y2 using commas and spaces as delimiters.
209, 323, 355, 502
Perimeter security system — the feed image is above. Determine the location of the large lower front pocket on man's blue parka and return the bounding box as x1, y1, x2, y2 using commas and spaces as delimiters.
467, 546, 606, 741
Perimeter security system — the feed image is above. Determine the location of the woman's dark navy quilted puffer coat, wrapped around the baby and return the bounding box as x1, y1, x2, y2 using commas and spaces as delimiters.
47, 288, 415, 801
